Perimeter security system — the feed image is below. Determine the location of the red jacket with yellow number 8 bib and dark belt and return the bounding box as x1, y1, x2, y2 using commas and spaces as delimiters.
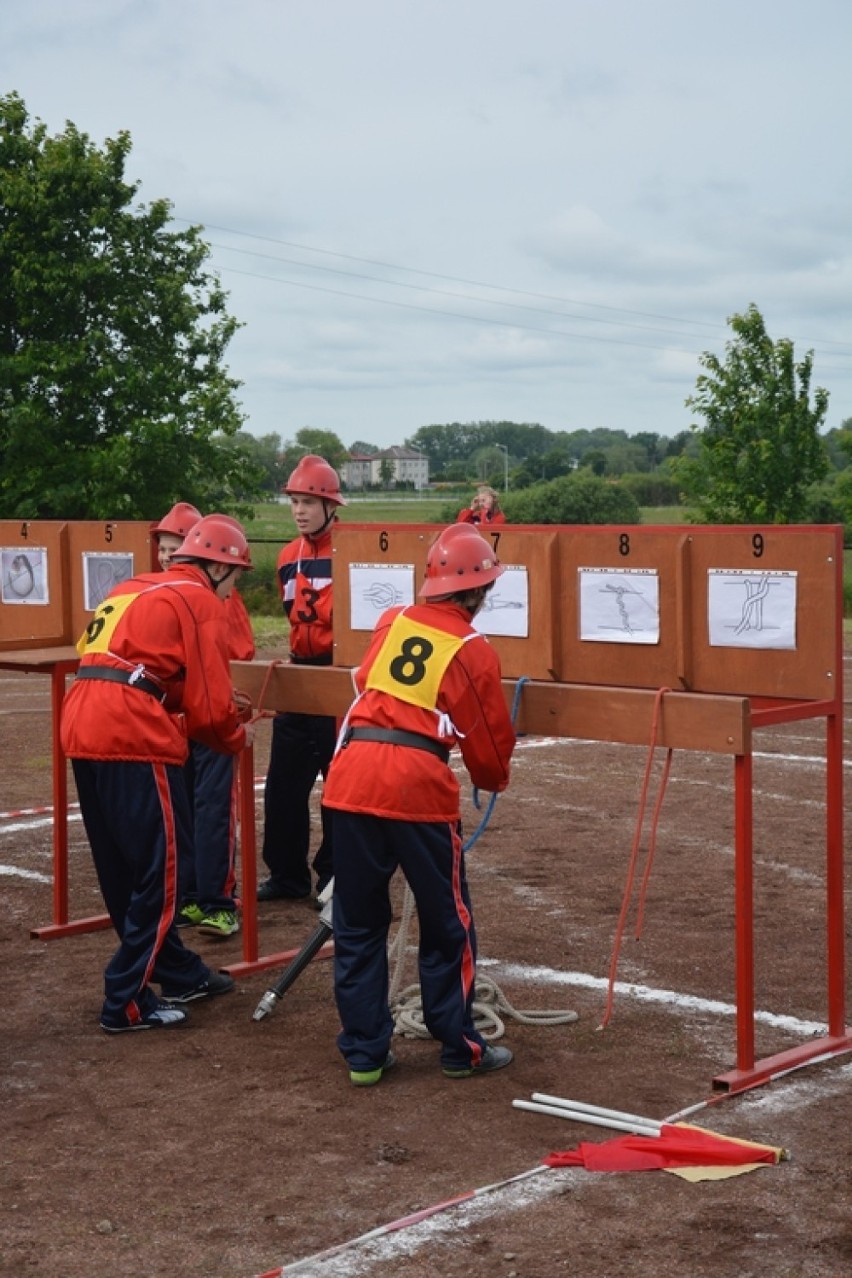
323, 602, 515, 822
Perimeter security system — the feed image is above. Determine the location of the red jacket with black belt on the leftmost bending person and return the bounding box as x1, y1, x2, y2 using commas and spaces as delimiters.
61, 564, 245, 763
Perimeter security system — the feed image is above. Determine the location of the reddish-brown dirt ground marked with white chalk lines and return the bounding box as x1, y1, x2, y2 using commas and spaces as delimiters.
0, 649, 852, 1278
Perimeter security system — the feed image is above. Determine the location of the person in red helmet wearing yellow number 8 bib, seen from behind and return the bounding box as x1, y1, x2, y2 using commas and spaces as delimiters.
323, 524, 515, 1086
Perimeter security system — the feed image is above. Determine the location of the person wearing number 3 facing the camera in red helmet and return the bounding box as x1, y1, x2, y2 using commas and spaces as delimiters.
257, 454, 346, 901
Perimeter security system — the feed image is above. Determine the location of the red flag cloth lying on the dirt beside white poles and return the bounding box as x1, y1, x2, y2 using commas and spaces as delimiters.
544, 1123, 784, 1172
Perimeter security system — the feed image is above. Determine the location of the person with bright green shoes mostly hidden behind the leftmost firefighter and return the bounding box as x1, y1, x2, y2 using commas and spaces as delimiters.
151, 501, 254, 939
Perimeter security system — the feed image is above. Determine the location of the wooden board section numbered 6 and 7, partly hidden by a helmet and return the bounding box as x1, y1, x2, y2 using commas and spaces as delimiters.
332, 524, 559, 679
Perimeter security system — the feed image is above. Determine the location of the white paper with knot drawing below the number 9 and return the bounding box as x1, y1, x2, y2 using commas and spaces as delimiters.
708, 567, 797, 649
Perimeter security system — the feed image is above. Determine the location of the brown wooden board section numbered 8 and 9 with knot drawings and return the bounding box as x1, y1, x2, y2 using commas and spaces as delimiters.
558, 527, 843, 699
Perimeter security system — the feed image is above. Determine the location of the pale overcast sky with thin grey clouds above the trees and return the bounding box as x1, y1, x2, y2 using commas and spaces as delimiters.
0, 0, 852, 447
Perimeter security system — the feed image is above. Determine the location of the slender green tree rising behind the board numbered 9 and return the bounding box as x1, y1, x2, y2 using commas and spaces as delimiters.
676, 304, 828, 524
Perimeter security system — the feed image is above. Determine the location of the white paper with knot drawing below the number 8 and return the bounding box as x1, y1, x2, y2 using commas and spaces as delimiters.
577, 567, 659, 644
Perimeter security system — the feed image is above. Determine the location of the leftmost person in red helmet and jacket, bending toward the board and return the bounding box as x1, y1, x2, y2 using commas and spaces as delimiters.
61, 515, 254, 1033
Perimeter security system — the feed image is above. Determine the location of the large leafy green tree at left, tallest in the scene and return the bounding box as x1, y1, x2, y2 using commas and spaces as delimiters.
0, 93, 255, 519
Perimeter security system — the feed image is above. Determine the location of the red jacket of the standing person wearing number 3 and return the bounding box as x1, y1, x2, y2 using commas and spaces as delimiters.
278, 528, 333, 665
